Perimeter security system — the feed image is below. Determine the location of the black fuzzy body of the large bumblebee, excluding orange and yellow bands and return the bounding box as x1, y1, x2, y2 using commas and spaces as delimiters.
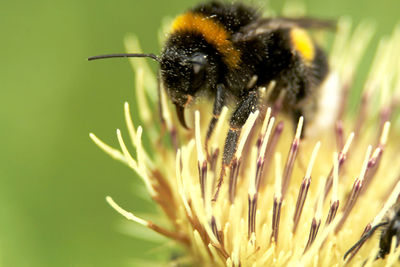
160, 2, 328, 164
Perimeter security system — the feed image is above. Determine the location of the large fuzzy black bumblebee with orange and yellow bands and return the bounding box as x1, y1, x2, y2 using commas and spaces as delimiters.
89, 2, 333, 166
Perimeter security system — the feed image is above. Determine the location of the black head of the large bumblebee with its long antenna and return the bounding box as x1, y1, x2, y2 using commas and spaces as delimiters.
88, 34, 221, 128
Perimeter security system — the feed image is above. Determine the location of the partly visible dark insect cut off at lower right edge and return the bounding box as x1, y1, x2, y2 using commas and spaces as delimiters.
343, 199, 400, 259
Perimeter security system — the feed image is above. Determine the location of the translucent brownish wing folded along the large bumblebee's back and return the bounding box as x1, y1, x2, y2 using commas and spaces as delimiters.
232, 17, 336, 42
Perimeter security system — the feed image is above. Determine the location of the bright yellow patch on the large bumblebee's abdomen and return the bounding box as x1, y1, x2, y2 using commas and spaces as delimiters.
290, 28, 315, 63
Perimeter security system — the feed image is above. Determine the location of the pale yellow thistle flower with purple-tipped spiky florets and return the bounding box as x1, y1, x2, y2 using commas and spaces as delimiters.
90, 16, 400, 266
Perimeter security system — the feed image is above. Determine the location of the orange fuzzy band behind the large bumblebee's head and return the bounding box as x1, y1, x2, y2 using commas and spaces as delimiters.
172, 12, 240, 68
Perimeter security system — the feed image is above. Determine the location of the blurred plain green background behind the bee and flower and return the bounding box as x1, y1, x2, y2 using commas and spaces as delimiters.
0, 0, 400, 266
